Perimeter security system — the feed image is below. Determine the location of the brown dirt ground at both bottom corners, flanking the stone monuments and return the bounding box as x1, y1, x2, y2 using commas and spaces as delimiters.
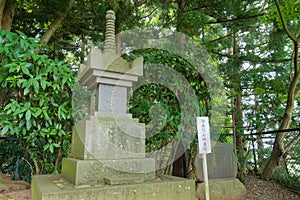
0, 175, 300, 200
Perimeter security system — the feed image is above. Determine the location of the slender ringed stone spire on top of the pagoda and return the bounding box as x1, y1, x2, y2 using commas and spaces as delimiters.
104, 10, 116, 54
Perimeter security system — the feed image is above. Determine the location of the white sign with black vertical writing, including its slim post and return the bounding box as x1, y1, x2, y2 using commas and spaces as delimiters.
197, 117, 211, 200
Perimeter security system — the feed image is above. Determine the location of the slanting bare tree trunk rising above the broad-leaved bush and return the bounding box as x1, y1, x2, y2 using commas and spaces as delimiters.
40, 0, 75, 45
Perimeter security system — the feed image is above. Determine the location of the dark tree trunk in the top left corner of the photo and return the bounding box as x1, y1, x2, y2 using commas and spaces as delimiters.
0, 0, 16, 31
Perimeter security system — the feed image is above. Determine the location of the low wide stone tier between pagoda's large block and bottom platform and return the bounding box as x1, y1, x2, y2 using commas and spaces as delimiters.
62, 158, 155, 185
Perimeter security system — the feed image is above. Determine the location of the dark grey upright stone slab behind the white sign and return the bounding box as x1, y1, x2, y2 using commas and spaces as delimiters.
195, 143, 237, 181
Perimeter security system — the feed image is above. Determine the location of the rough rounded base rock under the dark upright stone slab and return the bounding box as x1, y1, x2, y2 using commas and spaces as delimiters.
196, 178, 247, 200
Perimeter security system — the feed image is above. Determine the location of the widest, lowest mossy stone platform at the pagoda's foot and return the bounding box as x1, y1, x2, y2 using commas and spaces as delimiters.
31, 174, 195, 200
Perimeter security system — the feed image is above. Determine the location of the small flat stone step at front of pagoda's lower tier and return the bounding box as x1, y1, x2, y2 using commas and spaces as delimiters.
104, 175, 144, 185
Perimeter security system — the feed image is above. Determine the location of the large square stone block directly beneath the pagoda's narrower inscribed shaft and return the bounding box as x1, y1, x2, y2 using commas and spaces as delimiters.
71, 113, 145, 160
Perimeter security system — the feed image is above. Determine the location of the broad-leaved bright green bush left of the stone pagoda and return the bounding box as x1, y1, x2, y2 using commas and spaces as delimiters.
0, 31, 75, 179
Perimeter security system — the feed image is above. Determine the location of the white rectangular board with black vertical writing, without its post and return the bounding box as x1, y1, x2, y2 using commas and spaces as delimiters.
197, 117, 211, 154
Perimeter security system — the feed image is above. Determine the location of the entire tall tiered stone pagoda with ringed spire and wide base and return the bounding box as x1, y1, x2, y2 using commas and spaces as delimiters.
31, 11, 195, 200
